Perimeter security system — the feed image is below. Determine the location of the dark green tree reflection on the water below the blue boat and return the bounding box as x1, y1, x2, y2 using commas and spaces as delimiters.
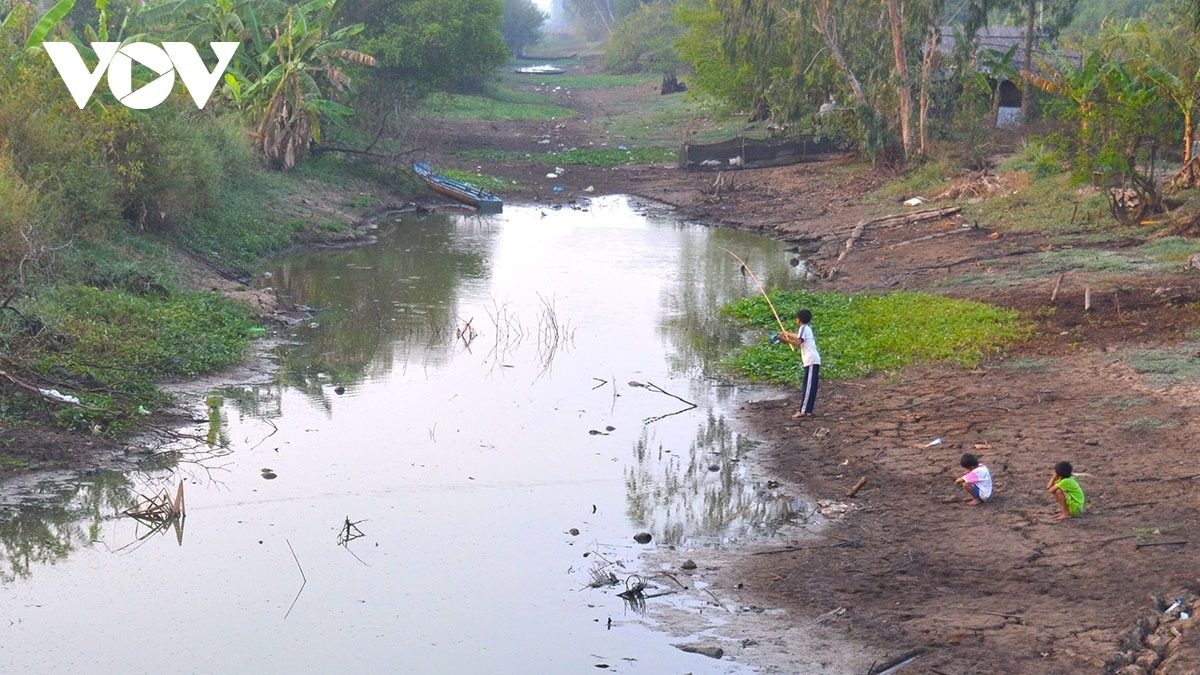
271, 214, 493, 407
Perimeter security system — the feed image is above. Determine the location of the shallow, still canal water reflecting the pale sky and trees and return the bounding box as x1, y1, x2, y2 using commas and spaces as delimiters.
0, 197, 803, 674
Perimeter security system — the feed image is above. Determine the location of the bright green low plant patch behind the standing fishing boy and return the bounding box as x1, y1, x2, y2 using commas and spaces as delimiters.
726, 292, 1030, 384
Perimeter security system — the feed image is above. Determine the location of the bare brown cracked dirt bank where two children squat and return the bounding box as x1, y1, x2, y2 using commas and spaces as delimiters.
424, 63, 1200, 675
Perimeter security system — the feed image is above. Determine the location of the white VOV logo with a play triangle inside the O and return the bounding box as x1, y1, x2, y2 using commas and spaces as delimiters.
42, 42, 240, 110
